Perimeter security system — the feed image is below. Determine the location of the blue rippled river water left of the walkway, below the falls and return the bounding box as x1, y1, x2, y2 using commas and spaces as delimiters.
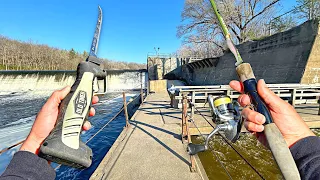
0, 92, 135, 179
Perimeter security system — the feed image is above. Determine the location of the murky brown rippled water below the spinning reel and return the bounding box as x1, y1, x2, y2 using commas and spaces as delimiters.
192, 129, 320, 180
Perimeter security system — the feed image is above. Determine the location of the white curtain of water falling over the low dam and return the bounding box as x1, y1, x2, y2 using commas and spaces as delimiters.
0, 70, 148, 94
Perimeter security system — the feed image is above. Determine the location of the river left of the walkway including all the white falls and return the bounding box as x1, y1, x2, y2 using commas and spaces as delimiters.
0, 72, 142, 179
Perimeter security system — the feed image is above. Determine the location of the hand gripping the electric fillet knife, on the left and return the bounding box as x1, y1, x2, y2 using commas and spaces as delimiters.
20, 86, 99, 154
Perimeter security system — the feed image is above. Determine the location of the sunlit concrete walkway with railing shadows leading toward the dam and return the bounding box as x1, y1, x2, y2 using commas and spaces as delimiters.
90, 93, 207, 180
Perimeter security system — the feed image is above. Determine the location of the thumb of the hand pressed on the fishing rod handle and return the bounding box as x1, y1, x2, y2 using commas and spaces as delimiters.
257, 79, 282, 107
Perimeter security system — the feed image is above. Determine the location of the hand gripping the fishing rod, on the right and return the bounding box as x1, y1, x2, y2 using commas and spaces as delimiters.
229, 79, 315, 147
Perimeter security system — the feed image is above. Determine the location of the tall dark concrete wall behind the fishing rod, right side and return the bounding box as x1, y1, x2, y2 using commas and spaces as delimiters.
166, 21, 320, 85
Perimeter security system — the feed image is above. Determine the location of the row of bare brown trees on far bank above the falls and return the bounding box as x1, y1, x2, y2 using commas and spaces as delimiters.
0, 35, 146, 70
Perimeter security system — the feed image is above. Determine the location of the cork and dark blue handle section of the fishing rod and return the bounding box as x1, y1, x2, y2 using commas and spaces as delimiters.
236, 63, 300, 180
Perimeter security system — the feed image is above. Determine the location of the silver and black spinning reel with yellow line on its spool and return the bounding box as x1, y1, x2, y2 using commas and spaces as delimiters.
188, 95, 243, 155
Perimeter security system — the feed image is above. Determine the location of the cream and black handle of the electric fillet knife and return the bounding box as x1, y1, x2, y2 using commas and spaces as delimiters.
39, 62, 94, 168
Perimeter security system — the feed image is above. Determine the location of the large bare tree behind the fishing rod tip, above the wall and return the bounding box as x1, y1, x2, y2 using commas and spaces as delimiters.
177, 0, 279, 54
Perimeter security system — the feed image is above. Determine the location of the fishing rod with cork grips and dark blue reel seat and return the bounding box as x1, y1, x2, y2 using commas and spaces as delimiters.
188, 0, 300, 180
